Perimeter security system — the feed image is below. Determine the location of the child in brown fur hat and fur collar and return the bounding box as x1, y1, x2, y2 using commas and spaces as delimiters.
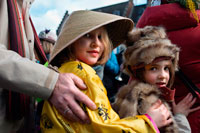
113, 26, 200, 133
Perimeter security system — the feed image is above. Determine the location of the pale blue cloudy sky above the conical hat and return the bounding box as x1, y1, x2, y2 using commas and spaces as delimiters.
30, 0, 146, 33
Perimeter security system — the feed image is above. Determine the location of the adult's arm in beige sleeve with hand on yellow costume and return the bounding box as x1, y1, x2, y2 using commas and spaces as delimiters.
0, 45, 95, 122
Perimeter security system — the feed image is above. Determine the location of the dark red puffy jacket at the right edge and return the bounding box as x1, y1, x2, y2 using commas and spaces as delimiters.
136, 3, 200, 133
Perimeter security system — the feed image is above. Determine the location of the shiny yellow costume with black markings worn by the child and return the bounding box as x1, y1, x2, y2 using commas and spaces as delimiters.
40, 61, 157, 133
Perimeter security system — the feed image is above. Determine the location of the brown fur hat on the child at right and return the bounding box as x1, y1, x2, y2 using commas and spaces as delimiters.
124, 26, 180, 86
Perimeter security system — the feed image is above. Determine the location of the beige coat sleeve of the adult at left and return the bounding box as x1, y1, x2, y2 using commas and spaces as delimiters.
0, 44, 58, 99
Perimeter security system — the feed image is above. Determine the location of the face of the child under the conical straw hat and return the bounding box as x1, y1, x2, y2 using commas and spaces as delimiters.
73, 27, 105, 65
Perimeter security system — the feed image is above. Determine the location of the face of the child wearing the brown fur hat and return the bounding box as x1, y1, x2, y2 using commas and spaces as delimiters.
144, 60, 172, 87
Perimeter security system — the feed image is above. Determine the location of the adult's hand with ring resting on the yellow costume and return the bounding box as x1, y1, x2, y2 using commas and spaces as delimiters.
49, 73, 96, 123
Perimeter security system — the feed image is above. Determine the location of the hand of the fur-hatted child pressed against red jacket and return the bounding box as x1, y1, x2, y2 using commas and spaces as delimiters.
172, 93, 200, 116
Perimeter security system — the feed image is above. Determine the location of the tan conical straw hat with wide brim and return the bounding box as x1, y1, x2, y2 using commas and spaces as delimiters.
50, 10, 134, 63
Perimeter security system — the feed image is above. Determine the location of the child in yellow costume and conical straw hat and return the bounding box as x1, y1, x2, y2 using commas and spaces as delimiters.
40, 11, 171, 133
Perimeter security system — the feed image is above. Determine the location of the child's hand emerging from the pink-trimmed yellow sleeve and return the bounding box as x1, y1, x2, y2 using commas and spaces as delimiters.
147, 100, 172, 128
